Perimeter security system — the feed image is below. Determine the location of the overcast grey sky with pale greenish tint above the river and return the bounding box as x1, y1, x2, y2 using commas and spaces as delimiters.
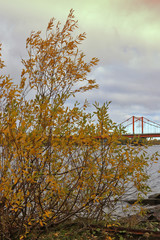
0, 0, 160, 126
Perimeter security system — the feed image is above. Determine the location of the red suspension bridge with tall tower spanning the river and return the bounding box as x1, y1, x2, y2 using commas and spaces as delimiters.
120, 116, 160, 138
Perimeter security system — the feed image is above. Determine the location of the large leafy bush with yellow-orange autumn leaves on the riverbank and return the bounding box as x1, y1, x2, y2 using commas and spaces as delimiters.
0, 10, 155, 239
